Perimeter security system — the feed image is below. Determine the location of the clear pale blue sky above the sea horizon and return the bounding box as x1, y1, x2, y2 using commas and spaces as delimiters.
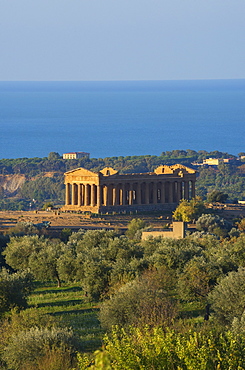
0, 0, 245, 81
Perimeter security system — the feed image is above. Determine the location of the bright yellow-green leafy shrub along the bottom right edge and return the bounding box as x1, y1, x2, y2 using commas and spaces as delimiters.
79, 327, 245, 370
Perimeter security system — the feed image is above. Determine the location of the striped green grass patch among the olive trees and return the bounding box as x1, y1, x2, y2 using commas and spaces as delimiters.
28, 284, 104, 352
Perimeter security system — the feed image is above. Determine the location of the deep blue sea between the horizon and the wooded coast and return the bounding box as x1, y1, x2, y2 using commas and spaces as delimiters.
0, 80, 245, 159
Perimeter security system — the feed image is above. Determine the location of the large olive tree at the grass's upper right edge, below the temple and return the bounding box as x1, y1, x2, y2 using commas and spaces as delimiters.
58, 230, 143, 299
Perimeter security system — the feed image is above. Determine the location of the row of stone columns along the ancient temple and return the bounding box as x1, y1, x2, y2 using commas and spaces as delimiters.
66, 180, 195, 207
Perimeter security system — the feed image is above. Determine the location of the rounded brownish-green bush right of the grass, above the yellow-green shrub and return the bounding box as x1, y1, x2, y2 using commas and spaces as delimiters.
100, 268, 177, 329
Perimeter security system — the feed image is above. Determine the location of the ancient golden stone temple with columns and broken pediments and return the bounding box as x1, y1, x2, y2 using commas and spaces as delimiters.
62, 164, 196, 213
